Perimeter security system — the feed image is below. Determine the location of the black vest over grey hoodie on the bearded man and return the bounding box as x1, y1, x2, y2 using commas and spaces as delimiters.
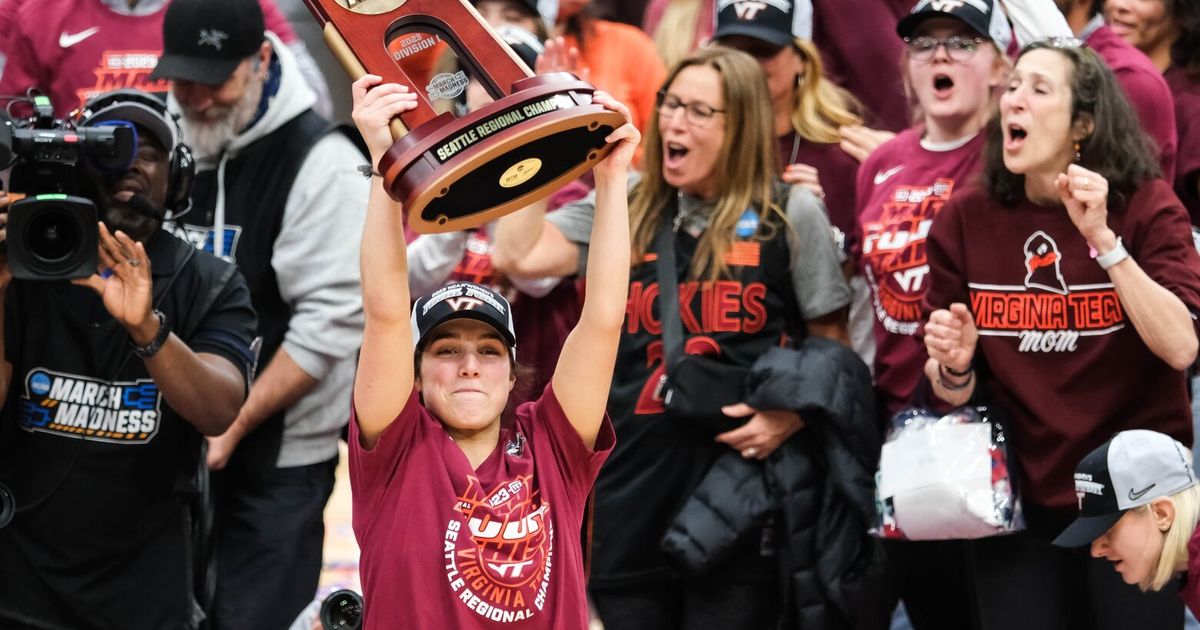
181, 109, 330, 472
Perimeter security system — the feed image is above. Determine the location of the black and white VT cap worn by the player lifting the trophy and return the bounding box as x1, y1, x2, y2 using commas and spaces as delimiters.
413, 282, 517, 356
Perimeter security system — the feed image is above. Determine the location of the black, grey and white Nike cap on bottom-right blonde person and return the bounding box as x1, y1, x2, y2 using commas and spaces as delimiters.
1054, 430, 1196, 547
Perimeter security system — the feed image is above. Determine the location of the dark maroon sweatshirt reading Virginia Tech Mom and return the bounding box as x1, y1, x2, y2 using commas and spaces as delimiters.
925, 180, 1200, 514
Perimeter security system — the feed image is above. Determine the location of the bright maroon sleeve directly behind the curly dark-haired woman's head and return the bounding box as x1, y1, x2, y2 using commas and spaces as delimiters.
1087, 26, 1178, 181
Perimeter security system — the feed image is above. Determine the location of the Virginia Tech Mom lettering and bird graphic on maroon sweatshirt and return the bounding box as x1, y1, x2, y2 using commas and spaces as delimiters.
967, 230, 1126, 353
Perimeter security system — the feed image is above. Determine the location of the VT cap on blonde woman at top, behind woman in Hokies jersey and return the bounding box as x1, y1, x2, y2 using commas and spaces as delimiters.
713, 0, 812, 47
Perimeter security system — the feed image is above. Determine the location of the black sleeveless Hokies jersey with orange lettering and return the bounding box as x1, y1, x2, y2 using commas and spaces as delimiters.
592, 190, 804, 588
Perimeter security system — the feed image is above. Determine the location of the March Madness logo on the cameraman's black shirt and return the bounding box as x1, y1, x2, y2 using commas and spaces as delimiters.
17, 368, 162, 444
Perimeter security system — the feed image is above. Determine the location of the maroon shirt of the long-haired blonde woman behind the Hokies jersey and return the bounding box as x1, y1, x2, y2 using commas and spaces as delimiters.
779, 131, 858, 252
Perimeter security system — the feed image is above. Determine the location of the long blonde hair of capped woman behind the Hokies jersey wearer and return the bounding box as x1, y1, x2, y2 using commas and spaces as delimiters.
792, 37, 863, 144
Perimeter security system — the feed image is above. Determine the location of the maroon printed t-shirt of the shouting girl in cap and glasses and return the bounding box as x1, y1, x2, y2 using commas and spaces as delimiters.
856, 128, 984, 418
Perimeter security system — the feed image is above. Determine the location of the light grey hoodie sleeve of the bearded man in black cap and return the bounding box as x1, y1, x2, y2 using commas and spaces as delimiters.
271, 132, 371, 380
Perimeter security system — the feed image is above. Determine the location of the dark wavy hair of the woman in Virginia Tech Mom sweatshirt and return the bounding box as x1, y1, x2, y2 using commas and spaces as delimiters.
983, 40, 1162, 210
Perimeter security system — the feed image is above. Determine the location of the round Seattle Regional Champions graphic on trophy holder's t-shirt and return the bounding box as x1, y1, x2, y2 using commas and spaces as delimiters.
443, 475, 554, 623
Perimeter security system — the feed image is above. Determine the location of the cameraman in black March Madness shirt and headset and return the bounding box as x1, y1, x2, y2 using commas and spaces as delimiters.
0, 90, 256, 629
